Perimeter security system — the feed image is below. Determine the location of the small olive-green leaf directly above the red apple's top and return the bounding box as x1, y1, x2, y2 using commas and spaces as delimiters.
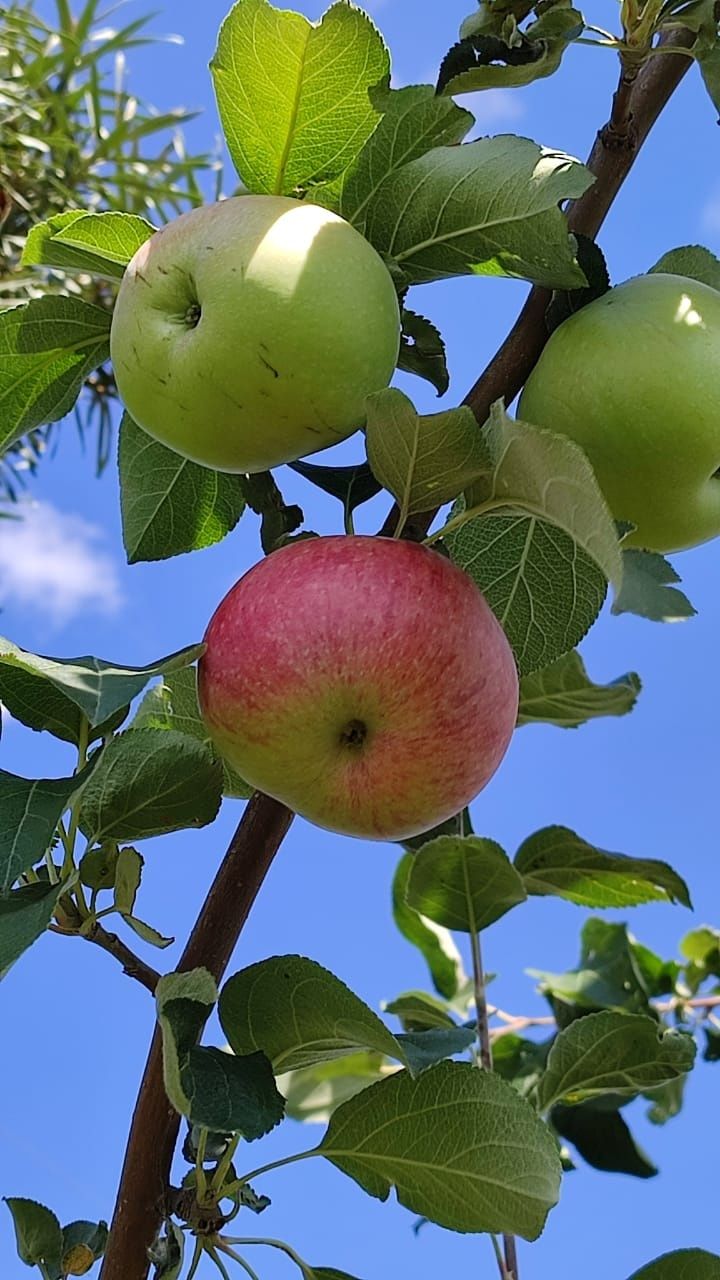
365, 387, 492, 527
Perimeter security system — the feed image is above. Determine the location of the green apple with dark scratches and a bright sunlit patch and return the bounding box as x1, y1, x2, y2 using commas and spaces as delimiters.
110, 196, 400, 472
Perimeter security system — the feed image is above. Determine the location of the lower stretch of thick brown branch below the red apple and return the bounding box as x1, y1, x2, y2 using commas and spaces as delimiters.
100, 792, 292, 1280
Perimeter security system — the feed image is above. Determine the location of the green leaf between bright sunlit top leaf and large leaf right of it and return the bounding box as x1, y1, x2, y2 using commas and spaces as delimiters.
313, 84, 473, 233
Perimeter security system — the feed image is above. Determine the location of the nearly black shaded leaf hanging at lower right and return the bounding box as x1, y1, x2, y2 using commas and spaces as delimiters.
550, 1102, 653, 1177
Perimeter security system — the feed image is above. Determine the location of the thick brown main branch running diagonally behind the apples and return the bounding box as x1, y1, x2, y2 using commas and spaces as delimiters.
100, 32, 693, 1280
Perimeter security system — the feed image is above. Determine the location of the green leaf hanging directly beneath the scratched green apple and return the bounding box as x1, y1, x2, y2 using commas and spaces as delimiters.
118, 413, 245, 564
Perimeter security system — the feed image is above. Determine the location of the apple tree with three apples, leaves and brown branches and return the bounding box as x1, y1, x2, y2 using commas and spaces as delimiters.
0, 0, 720, 1280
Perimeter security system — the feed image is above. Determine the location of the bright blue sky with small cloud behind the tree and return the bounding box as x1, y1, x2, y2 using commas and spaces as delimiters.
0, 0, 720, 1280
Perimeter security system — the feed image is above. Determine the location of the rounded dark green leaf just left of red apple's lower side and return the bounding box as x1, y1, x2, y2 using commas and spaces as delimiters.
79, 728, 222, 842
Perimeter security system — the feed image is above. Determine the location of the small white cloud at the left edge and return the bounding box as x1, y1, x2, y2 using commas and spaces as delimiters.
0, 502, 122, 627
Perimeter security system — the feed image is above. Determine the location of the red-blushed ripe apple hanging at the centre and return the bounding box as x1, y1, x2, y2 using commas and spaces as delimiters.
199, 535, 518, 840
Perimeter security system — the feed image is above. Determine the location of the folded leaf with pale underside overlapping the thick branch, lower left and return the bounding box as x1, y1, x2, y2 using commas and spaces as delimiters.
155, 969, 218, 1115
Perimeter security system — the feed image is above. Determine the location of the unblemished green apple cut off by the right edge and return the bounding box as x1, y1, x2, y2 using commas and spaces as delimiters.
518, 273, 720, 552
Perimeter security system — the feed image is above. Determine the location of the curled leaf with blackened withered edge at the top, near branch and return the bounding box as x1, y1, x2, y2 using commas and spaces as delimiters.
437, 5, 584, 93
